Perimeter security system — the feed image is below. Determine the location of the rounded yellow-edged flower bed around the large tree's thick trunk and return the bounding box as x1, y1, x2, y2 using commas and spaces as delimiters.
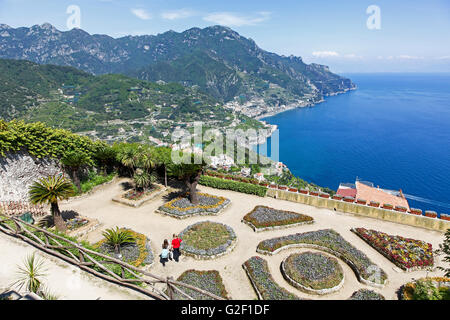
159, 193, 230, 219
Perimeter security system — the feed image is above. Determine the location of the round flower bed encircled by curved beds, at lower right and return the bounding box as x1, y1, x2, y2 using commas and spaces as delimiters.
281, 252, 344, 294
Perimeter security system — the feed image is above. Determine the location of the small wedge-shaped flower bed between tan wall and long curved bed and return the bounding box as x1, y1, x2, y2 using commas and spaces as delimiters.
242, 206, 314, 232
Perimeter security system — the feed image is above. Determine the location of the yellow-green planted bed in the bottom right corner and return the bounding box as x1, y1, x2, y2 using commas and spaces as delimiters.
399, 277, 450, 300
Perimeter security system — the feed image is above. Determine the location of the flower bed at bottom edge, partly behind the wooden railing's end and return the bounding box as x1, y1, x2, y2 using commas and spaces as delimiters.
174, 270, 229, 300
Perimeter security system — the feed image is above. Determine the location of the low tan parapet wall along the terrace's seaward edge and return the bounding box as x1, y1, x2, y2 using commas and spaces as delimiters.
267, 188, 450, 232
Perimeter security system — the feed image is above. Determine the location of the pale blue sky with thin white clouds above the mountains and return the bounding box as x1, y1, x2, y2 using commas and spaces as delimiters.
0, 0, 450, 73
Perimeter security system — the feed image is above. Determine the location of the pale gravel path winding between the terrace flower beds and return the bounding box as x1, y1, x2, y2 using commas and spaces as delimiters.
51, 179, 444, 299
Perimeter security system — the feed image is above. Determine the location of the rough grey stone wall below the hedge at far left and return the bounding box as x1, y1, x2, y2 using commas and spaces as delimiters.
0, 152, 61, 201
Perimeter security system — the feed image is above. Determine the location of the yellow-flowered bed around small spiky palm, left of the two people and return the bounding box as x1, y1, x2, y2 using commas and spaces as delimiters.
93, 228, 154, 267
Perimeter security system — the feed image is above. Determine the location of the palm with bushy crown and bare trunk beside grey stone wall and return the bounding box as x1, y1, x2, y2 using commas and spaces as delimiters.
29, 176, 74, 231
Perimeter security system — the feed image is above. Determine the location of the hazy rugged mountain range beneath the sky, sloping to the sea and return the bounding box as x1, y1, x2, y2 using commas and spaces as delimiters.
0, 23, 355, 107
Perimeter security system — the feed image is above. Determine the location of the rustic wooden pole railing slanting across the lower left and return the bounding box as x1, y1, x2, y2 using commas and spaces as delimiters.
0, 214, 225, 300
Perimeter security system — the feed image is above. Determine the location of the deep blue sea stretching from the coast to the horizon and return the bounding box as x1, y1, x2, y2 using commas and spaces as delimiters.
264, 74, 450, 214
